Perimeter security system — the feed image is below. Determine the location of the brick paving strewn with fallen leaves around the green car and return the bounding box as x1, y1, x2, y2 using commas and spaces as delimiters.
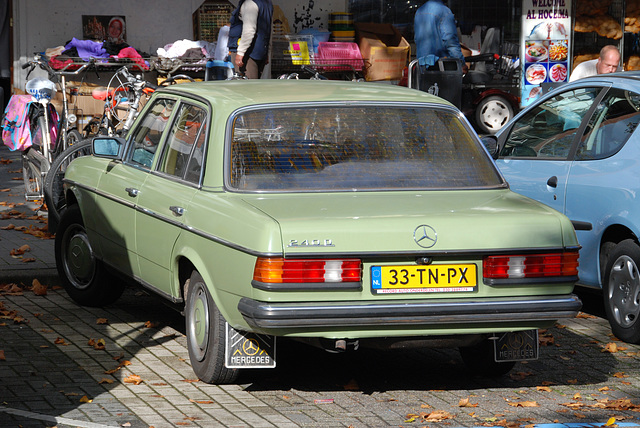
0, 148, 640, 428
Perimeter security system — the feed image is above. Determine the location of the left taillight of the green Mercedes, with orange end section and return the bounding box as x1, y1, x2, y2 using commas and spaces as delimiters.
253, 257, 362, 283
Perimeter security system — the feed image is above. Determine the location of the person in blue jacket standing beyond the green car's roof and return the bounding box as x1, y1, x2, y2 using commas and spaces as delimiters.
414, 0, 466, 72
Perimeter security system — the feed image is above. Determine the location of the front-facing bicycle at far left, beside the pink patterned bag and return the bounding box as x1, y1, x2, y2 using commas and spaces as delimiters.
11, 55, 93, 201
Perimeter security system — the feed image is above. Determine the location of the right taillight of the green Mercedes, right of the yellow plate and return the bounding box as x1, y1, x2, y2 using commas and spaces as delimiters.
482, 251, 578, 279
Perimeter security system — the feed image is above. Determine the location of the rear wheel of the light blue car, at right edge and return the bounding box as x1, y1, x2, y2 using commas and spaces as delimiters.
602, 239, 640, 344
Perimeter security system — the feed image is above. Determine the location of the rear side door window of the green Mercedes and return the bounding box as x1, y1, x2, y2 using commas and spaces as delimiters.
159, 104, 206, 182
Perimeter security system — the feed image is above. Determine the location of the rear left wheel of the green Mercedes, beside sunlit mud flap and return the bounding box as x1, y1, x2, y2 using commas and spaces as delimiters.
185, 271, 239, 385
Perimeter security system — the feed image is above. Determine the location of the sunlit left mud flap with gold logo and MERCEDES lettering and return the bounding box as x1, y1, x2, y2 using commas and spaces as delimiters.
224, 323, 276, 369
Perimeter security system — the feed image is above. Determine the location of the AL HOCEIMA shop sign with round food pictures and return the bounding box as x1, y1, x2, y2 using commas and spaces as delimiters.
520, 0, 572, 107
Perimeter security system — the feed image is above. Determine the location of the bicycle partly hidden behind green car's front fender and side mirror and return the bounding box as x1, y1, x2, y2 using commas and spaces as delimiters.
44, 66, 194, 233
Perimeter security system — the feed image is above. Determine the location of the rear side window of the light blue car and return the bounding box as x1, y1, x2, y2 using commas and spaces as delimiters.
576, 88, 640, 160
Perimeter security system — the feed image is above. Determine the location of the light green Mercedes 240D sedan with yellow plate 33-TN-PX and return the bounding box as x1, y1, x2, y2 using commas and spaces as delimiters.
55, 80, 581, 383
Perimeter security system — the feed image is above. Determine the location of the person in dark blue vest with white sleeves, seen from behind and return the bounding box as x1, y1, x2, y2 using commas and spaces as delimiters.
229, 0, 273, 79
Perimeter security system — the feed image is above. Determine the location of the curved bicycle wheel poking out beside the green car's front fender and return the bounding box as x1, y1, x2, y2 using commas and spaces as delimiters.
44, 140, 91, 233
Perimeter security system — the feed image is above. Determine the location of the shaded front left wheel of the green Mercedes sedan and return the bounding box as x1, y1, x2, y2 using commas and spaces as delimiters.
55, 205, 125, 307
